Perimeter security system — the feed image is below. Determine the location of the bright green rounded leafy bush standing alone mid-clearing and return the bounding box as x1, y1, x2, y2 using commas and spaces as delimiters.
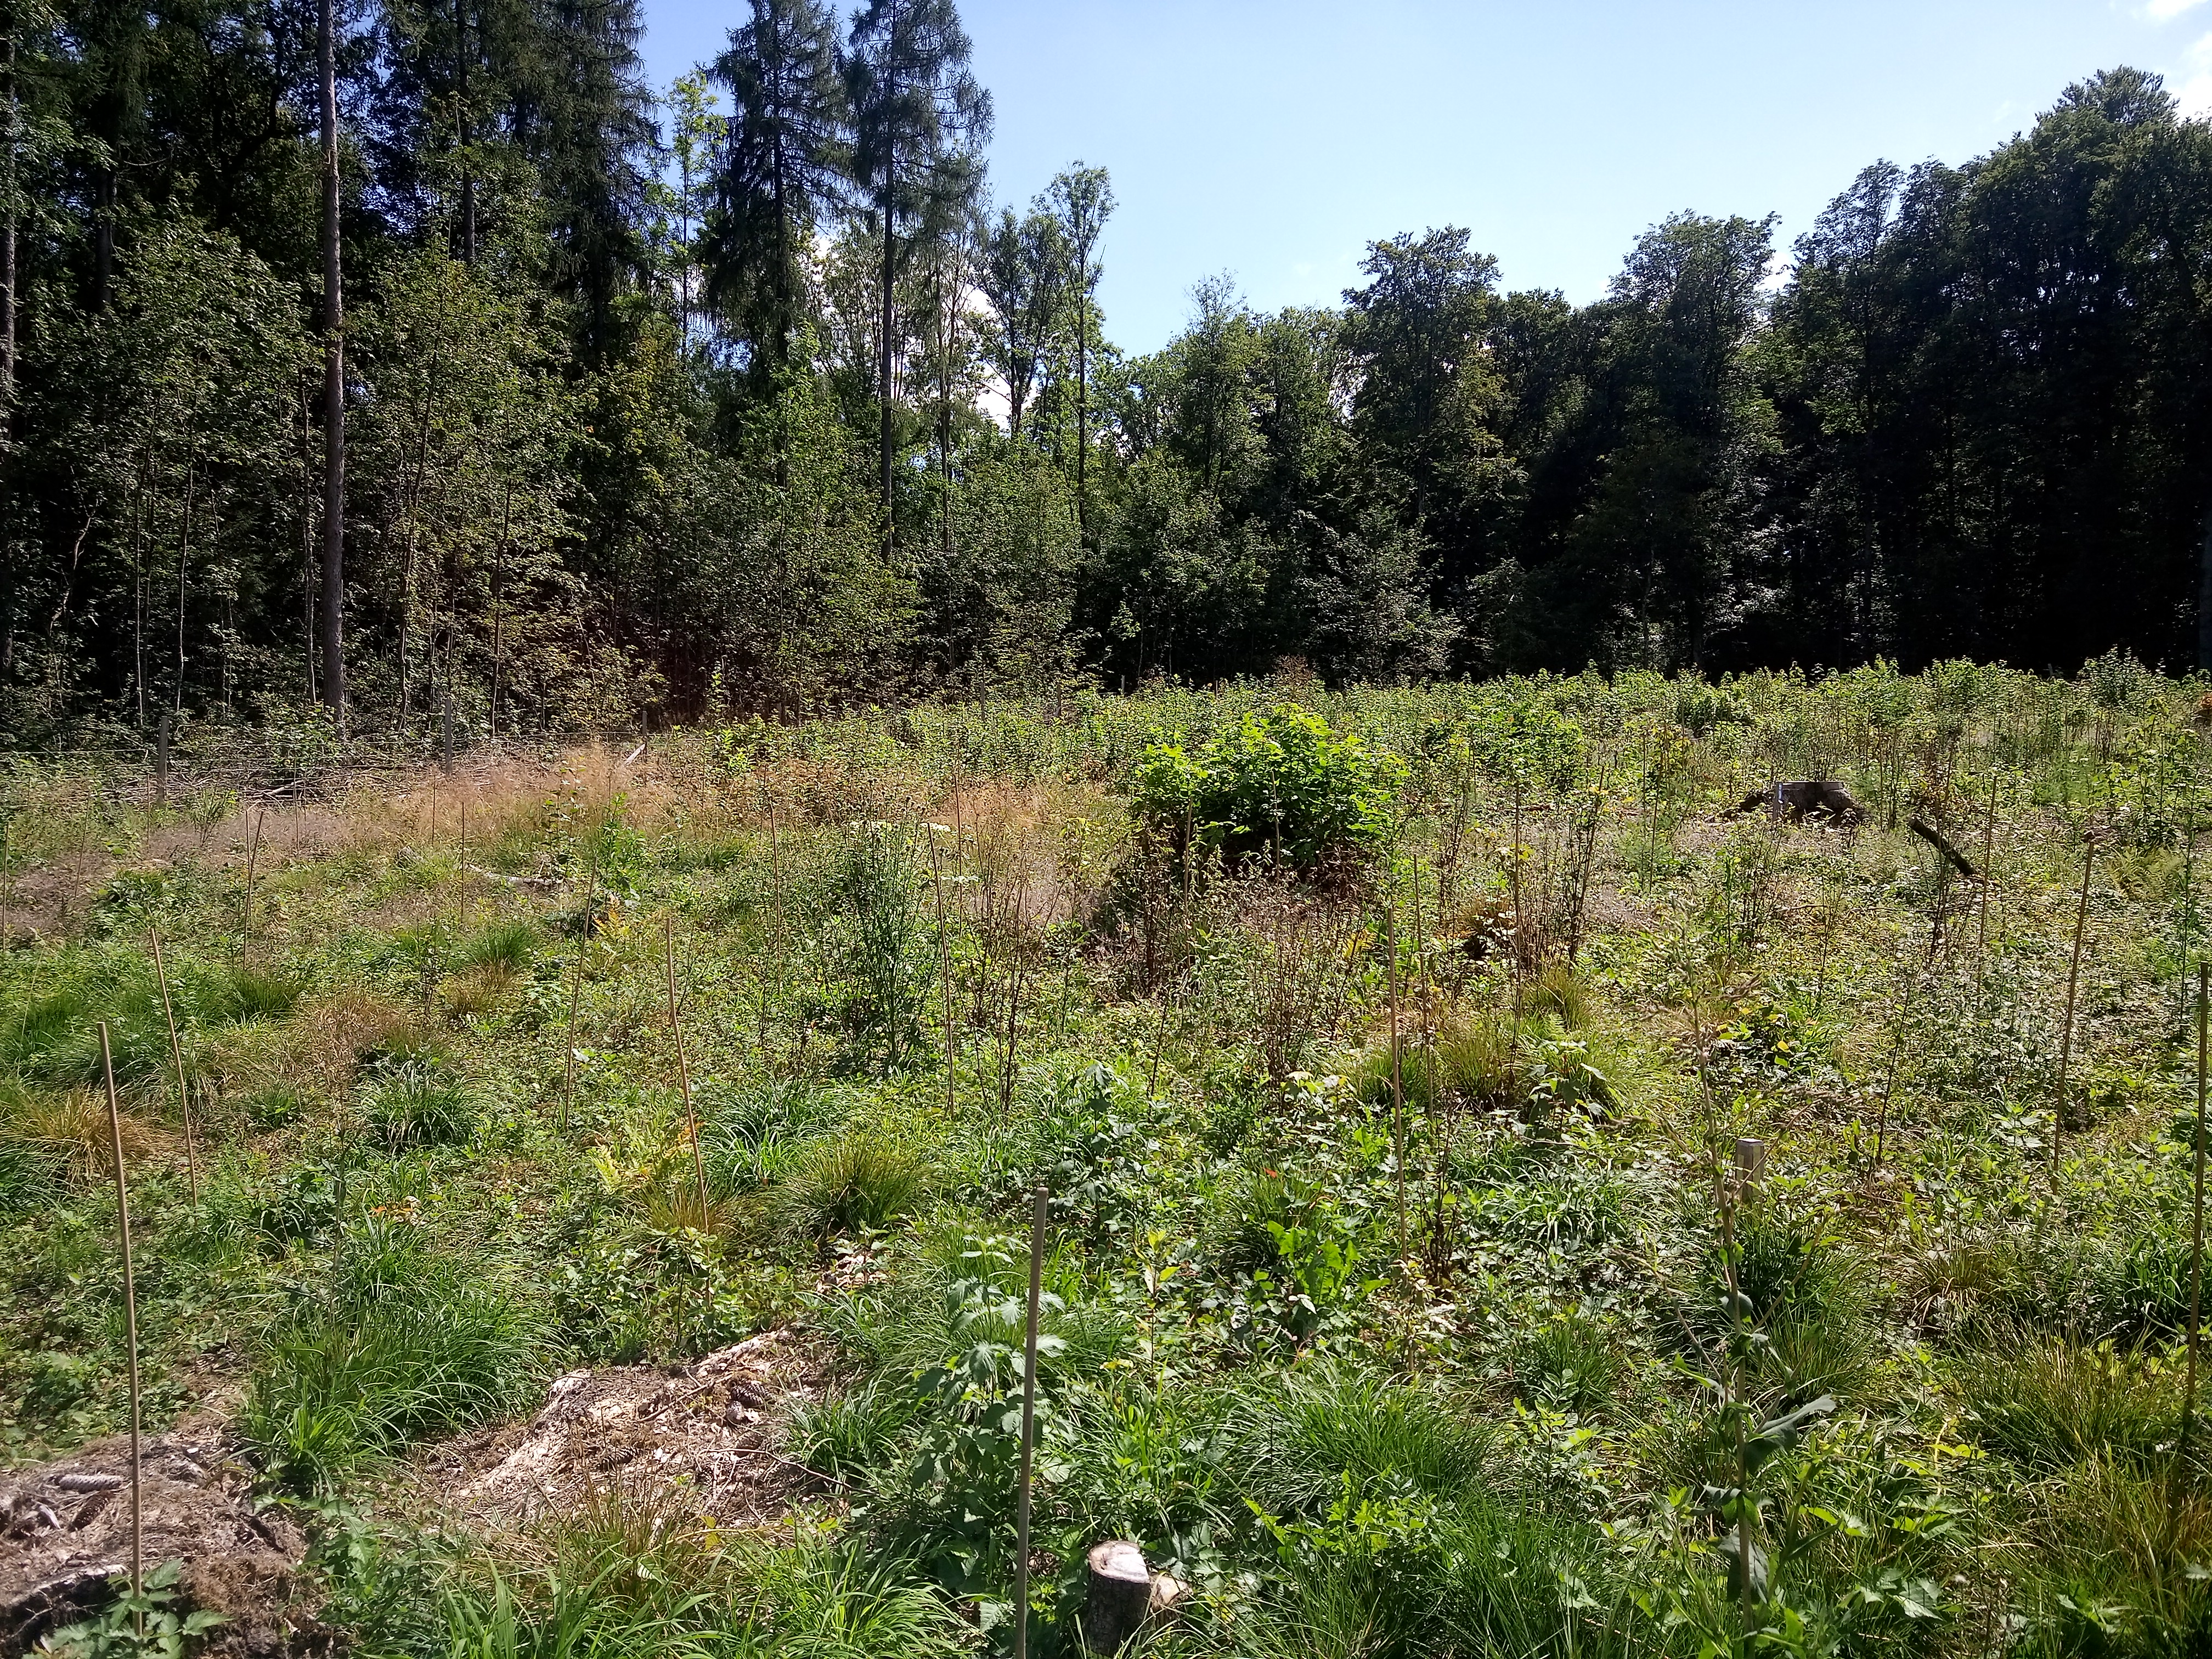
1135, 703, 1404, 870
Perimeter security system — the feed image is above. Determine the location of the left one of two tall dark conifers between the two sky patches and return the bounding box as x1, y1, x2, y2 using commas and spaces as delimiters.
703, 0, 849, 376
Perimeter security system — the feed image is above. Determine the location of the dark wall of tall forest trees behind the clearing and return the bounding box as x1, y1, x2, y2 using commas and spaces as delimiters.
0, 0, 2212, 741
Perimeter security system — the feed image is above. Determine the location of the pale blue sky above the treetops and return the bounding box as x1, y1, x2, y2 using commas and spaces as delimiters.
646, 0, 2212, 352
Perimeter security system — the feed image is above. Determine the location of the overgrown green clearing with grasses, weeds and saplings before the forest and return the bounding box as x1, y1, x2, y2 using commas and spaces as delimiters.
0, 657, 2212, 1659
